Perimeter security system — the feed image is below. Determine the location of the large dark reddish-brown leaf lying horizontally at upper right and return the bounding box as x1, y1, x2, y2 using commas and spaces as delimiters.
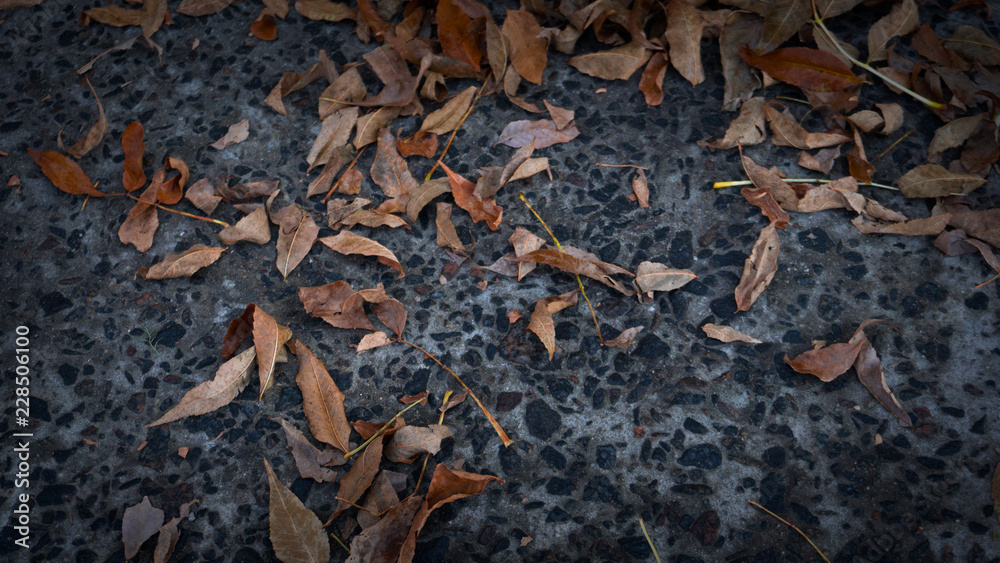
740, 47, 864, 92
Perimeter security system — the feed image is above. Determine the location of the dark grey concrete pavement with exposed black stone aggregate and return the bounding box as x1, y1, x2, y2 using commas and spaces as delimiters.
0, 0, 1000, 562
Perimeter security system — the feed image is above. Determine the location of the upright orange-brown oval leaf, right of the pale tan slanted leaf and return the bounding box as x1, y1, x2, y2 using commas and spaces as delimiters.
295, 341, 351, 454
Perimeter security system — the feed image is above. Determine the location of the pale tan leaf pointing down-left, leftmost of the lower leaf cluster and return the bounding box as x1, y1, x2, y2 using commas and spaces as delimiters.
146, 348, 257, 428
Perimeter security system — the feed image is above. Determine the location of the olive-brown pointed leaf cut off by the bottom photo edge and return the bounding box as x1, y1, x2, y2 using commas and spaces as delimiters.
264, 459, 330, 562
